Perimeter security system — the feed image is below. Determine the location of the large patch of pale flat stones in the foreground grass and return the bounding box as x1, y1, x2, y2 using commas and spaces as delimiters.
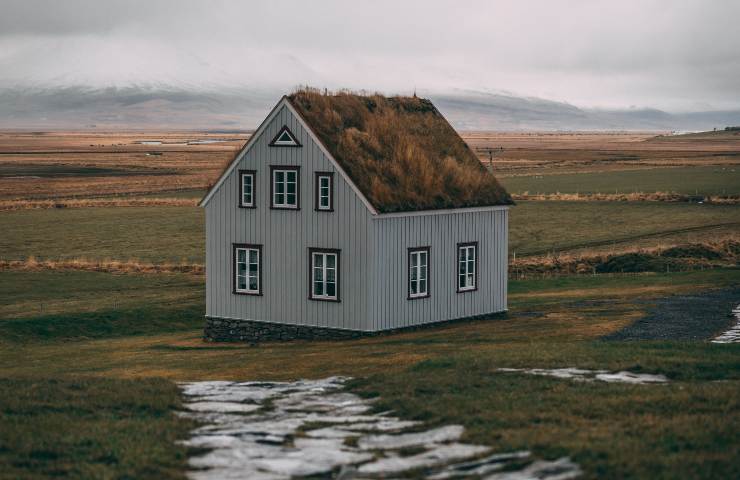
178, 377, 582, 480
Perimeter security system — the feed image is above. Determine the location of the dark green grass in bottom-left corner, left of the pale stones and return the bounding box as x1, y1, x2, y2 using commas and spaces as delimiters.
0, 377, 192, 479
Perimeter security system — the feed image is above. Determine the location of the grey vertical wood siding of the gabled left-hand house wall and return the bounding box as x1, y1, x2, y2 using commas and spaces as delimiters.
206, 106, 374, 330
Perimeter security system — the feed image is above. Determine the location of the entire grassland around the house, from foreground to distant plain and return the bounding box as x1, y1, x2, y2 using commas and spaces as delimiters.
0, 132, 740, 479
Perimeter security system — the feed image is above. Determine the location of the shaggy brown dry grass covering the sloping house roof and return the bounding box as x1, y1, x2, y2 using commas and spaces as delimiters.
288, 89, 511, 212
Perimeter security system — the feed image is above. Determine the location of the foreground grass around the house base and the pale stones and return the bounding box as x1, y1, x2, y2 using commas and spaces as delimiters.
0, 270, 740, 478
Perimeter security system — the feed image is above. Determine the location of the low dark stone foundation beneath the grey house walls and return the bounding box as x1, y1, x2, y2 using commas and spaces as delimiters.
203, 312, 506, 343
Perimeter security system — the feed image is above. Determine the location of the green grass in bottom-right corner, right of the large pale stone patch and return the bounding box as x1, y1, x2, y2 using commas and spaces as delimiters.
358, 342, 740, 479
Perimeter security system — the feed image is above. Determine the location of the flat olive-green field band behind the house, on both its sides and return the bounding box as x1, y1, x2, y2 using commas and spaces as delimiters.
0, 201, 740, 263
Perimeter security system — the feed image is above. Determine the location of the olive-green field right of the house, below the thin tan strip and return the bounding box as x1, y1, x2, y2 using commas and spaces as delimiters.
509, 201, 740, 255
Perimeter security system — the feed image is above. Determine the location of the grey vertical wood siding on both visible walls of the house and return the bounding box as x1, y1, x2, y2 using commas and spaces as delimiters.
206, 106, 508, 331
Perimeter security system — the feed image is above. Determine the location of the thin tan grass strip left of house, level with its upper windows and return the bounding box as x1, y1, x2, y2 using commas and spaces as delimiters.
0, 197, 198, 211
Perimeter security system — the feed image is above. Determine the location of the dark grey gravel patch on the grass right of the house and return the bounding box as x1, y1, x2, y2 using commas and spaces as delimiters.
603, 286, 740, 340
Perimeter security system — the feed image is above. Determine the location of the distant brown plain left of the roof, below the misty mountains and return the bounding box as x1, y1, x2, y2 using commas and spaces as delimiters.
0, 132, 249, 200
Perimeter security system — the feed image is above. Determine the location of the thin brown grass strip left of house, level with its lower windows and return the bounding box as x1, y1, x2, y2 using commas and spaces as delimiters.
0, 257, 206, 275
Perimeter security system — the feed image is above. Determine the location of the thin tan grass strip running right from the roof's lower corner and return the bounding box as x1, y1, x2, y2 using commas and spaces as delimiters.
511, 192, 740, 205
